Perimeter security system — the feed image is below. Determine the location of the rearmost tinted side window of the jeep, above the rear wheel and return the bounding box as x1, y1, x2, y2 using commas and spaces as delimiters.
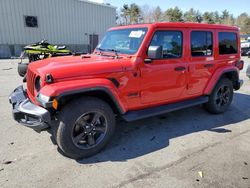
219, 32, 238, 55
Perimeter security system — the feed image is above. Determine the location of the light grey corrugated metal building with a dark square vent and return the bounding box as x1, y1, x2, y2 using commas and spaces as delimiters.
0, 0, 116, 58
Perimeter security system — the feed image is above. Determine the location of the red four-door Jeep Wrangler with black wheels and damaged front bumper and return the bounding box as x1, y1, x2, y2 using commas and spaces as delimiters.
9, 23, 243, 158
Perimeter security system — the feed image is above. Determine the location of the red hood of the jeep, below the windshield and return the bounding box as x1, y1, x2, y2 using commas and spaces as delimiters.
29, 55, 126, 80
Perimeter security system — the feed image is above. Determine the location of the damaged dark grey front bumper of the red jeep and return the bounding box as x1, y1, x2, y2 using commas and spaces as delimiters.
9, 86, 51, 132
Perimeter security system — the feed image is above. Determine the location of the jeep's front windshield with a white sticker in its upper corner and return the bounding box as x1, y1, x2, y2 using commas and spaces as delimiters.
96, 28, 147, 54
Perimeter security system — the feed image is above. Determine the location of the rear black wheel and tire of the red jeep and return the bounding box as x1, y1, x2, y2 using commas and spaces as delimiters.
204, 78, 234, 114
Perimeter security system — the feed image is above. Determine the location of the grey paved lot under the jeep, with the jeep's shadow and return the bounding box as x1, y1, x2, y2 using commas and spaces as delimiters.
0, 58, 250, 188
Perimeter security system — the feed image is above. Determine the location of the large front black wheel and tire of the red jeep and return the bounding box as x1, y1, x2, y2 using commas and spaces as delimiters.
56, 97, 115, 159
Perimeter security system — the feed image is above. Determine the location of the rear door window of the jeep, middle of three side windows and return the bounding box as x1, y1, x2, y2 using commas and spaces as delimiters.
191, 31, 213, 56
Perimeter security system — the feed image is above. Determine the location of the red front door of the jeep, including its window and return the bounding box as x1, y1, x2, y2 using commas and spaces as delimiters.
141, 29, 187, 104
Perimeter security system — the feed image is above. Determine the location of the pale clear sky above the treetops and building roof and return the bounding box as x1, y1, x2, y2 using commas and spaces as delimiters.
91, 0, 250, 16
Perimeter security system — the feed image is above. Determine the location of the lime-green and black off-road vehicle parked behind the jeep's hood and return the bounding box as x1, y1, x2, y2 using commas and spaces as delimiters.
18, 40, 72, 77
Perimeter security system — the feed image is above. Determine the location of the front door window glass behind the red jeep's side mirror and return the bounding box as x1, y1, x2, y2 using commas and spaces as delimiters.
150, 31, 182, 59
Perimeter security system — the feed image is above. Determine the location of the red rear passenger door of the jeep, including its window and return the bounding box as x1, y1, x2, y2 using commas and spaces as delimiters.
187, 29, 215, 96
